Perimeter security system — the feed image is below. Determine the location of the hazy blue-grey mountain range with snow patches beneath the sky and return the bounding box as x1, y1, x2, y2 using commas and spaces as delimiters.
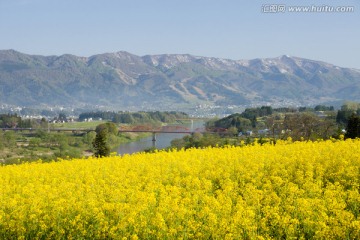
0, 50, 360, 110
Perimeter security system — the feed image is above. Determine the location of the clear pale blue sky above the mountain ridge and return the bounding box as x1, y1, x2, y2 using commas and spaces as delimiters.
0, 0, 360, 69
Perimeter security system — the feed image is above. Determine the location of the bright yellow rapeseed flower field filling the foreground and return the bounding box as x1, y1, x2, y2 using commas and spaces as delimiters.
0, 140, 360, 239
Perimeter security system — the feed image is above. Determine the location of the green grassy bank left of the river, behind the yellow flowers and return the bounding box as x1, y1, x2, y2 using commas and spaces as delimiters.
0, 121, 150, 164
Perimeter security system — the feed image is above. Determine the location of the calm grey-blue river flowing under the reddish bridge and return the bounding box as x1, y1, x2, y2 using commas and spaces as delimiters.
114, 120, 204, 155
